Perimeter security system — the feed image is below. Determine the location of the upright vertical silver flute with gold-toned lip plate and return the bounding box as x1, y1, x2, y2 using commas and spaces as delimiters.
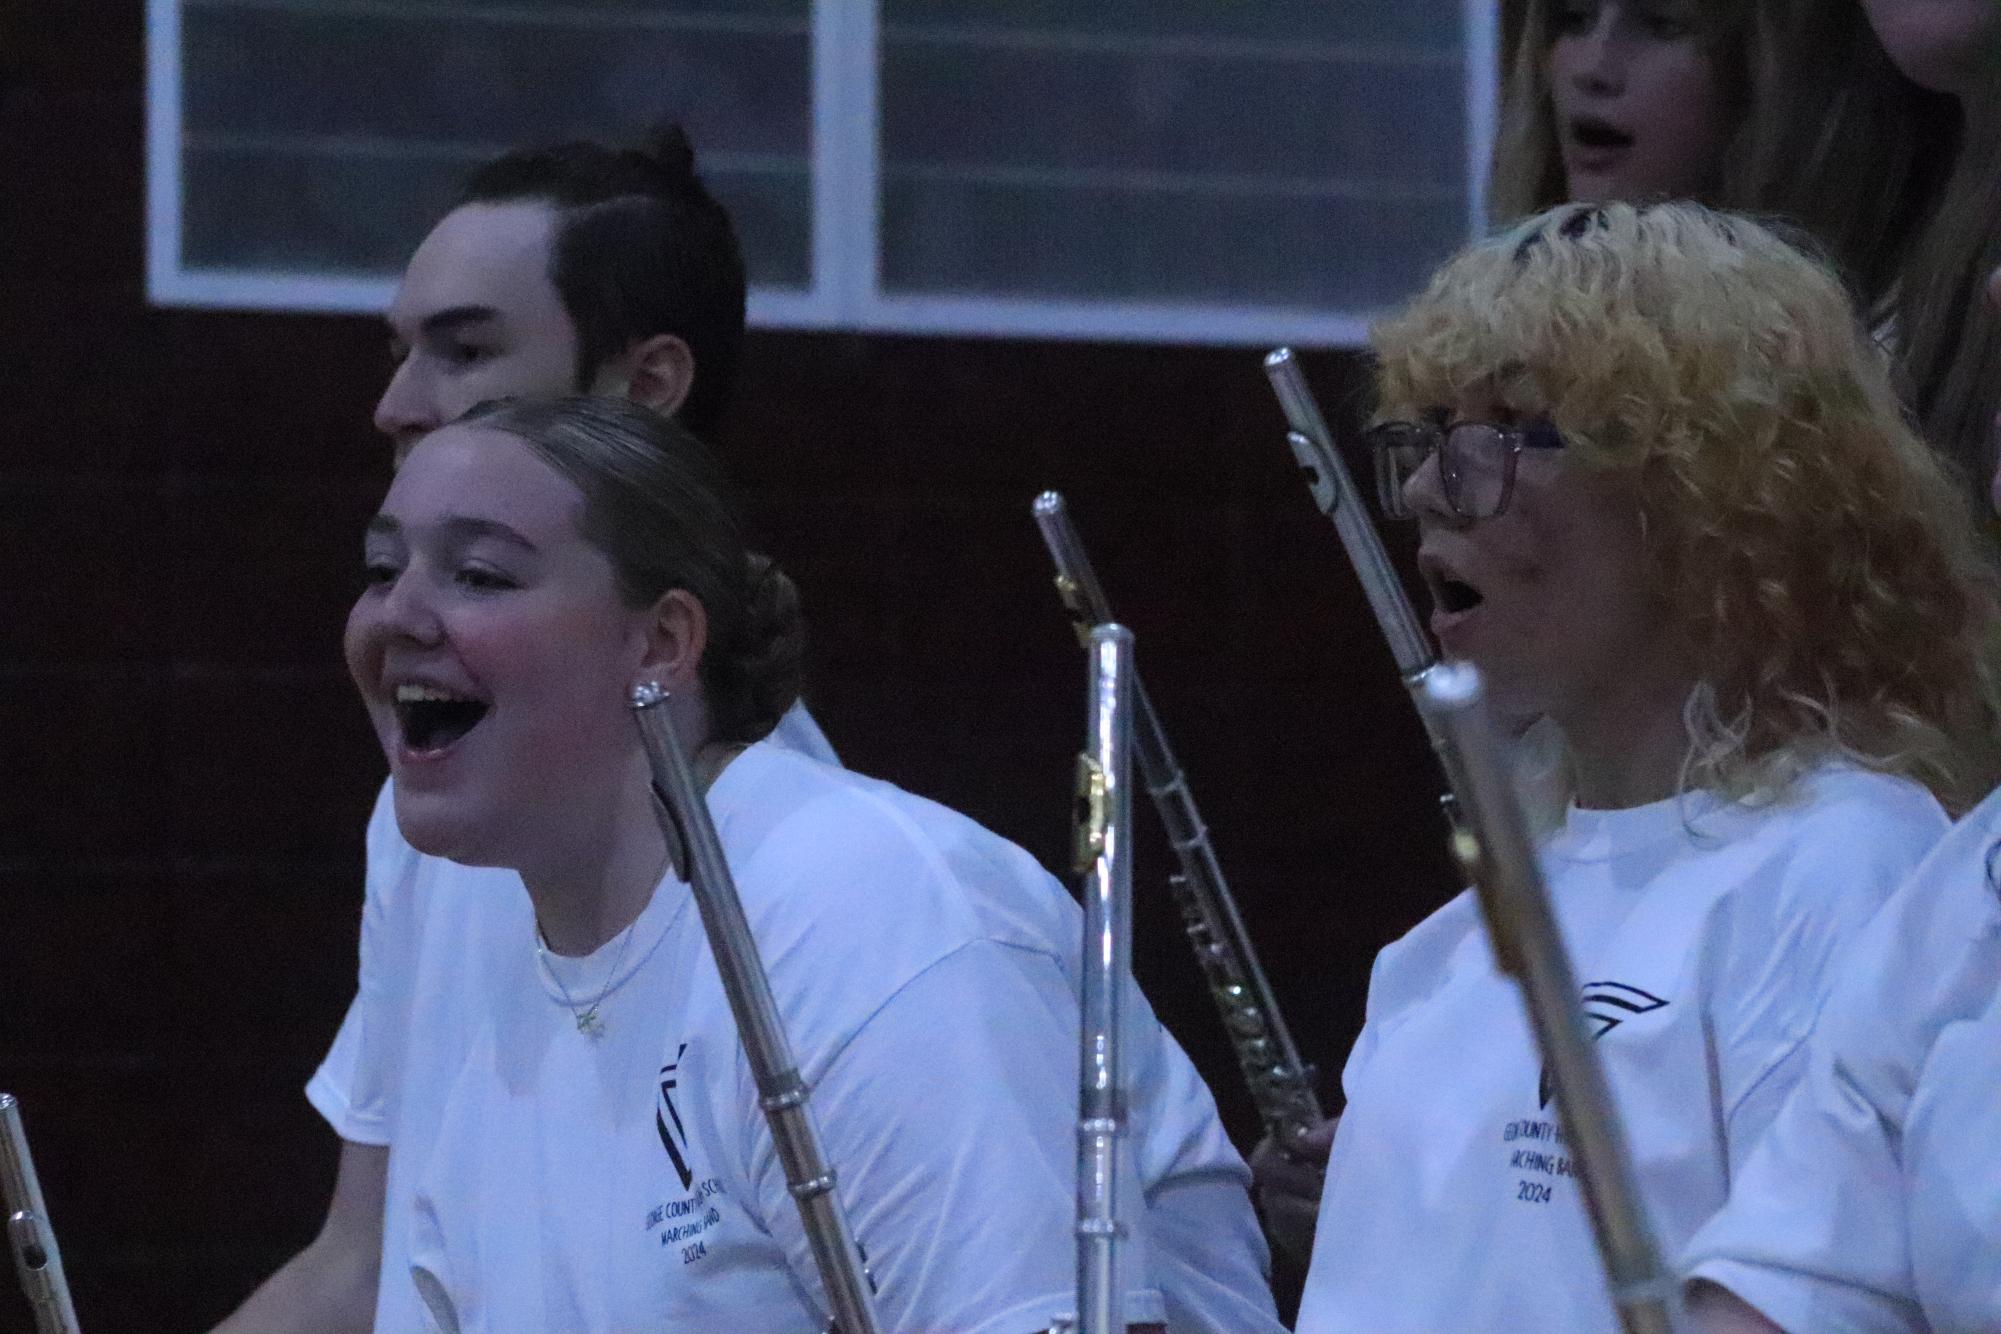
1075, 624, 1135, 1334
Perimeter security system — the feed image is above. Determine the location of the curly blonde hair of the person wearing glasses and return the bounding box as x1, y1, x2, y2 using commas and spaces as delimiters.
1373, 204, 2001, 814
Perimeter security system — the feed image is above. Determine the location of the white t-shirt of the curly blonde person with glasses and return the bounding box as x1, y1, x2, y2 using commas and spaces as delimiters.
1299, 768, 1947, 1334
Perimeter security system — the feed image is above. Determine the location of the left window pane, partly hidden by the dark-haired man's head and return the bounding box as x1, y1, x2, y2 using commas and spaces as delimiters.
182, 0, 812, 286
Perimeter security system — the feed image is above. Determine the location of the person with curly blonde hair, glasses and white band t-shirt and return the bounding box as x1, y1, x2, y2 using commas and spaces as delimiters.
1299, 204, 2001, 1334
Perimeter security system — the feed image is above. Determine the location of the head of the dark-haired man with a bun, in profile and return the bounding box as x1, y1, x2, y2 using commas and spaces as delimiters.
376, 126, 744, 456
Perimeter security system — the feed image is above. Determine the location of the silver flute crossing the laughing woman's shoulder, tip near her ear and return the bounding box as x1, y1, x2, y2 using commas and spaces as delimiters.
632, 684, 882, 1334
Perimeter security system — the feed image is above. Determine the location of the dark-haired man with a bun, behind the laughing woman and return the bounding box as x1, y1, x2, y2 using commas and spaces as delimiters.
220, 124, 838, 1334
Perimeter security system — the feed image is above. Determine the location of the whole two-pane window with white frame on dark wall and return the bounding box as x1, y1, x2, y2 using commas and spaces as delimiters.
148, 0, 1497, 342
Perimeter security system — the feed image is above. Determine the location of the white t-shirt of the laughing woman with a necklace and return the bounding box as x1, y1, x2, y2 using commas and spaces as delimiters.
312, 746, 1281, 1334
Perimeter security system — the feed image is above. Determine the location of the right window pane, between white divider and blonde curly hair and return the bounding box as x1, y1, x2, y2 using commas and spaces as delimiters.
880, 0, 1469, 310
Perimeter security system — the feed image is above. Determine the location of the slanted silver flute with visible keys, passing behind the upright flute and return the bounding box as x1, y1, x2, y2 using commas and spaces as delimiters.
1035, 490, 1325, 1150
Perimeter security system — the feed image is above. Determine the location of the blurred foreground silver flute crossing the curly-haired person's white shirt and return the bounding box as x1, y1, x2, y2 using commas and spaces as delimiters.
1417, 662, 1677, 1334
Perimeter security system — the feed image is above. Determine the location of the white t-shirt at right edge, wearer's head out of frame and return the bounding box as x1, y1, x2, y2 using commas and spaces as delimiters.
1685, 794, 2001, 1334
